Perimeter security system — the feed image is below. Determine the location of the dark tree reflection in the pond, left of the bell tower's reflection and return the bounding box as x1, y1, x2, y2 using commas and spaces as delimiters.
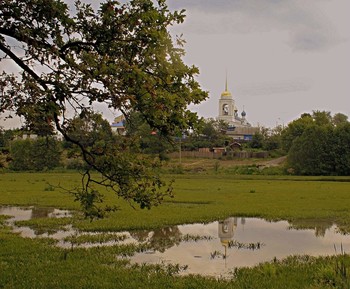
130, 226, 182, 253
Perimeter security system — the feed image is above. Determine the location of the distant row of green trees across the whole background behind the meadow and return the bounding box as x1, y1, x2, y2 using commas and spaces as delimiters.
0, 111, 350, 175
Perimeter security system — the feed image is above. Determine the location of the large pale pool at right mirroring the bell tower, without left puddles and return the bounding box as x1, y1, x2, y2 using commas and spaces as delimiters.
131, 218, 350, 277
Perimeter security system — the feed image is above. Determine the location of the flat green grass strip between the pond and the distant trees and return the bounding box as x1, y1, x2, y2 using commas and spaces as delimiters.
0, 173, 350, 231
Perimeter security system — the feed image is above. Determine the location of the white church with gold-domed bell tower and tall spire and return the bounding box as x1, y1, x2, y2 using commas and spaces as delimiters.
218, 79, 259, 141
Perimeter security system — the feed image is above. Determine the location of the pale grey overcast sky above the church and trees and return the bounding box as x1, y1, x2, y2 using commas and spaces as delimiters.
1, 0, 350, 127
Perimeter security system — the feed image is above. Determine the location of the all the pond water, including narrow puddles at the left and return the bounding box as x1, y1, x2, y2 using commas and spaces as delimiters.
0, 207, 350, 277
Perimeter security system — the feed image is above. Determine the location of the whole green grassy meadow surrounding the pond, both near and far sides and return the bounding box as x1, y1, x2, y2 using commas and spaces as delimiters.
0, 167, 350, 288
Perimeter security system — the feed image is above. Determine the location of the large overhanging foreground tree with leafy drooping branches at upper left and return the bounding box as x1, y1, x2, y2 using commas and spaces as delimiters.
0, 0, 207, 216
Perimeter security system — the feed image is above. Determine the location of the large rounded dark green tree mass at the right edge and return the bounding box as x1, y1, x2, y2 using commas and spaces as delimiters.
282, 111, 350, 175
